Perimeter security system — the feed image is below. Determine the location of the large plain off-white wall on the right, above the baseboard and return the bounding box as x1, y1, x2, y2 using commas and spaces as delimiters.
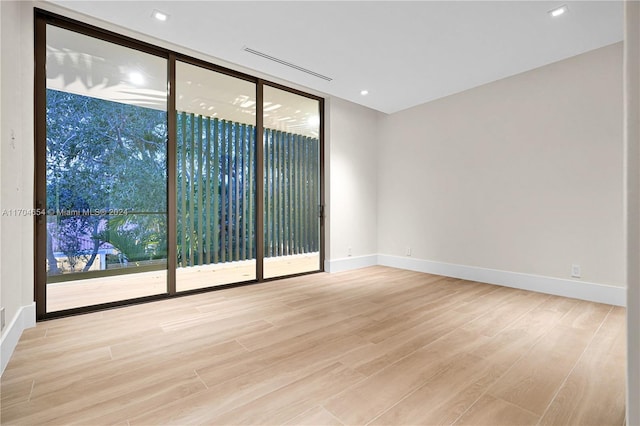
378, 43, 625, 293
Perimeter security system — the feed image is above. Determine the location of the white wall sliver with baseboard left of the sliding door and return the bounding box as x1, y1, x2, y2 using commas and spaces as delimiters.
0, 1, 35, 371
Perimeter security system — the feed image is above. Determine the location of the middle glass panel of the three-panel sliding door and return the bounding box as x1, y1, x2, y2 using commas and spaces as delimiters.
176, 61, 256, 291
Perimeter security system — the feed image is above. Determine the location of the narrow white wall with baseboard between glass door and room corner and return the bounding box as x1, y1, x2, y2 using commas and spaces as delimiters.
325, 98, 383, 272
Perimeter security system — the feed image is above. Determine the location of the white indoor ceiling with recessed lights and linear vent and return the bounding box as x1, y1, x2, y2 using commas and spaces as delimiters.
51, 0, 623, 113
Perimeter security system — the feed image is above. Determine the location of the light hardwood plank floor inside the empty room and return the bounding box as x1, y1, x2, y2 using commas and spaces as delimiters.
0, 267, 625, 426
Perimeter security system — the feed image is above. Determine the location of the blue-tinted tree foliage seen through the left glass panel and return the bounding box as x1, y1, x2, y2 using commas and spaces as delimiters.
47, 89, 167, 273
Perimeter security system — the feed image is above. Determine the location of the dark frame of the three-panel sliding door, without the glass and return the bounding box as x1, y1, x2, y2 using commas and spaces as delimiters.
33, 8, 325, 320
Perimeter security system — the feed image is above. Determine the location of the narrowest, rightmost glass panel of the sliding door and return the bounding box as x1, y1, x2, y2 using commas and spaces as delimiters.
263, 85, 320, 278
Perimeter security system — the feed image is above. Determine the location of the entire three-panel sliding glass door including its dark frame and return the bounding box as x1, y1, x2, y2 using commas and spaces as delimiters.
34, 11, 323, 319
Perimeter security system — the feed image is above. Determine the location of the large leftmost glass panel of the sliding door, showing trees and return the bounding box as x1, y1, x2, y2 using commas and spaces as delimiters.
45, 25, 167, 312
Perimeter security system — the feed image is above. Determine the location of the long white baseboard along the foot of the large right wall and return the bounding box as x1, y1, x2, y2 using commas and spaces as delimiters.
377, 254, 627, 306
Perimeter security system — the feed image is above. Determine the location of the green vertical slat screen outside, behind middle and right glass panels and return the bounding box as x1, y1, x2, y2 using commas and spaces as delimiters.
177, 112, 320, 267
